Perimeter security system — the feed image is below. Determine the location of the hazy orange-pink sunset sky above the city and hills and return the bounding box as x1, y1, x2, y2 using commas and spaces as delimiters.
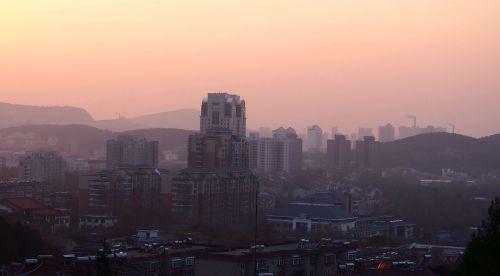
0, 0, 500, 136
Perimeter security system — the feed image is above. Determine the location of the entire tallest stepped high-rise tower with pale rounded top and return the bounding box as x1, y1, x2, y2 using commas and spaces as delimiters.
172, 93, 258, 226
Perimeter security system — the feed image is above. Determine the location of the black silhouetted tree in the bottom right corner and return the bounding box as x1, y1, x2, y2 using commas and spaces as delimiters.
457, 198, 500, 275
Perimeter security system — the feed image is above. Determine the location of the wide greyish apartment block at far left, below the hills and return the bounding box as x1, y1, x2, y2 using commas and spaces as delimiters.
18, 151, 65, 185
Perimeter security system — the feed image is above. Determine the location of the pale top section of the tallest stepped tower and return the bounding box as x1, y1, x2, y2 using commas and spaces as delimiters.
200, 93, 246, 137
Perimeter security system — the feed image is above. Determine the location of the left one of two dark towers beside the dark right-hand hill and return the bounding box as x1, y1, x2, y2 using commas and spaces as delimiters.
326, 135, 352, 172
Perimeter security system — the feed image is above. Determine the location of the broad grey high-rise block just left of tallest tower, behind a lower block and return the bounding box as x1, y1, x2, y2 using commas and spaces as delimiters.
106, 135, 158, 169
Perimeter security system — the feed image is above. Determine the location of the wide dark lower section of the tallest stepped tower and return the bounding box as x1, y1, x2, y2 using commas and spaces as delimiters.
172, 168, 258, 226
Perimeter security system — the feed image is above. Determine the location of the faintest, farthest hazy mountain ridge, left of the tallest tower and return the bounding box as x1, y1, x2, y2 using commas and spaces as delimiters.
0, 103, 199, 131
